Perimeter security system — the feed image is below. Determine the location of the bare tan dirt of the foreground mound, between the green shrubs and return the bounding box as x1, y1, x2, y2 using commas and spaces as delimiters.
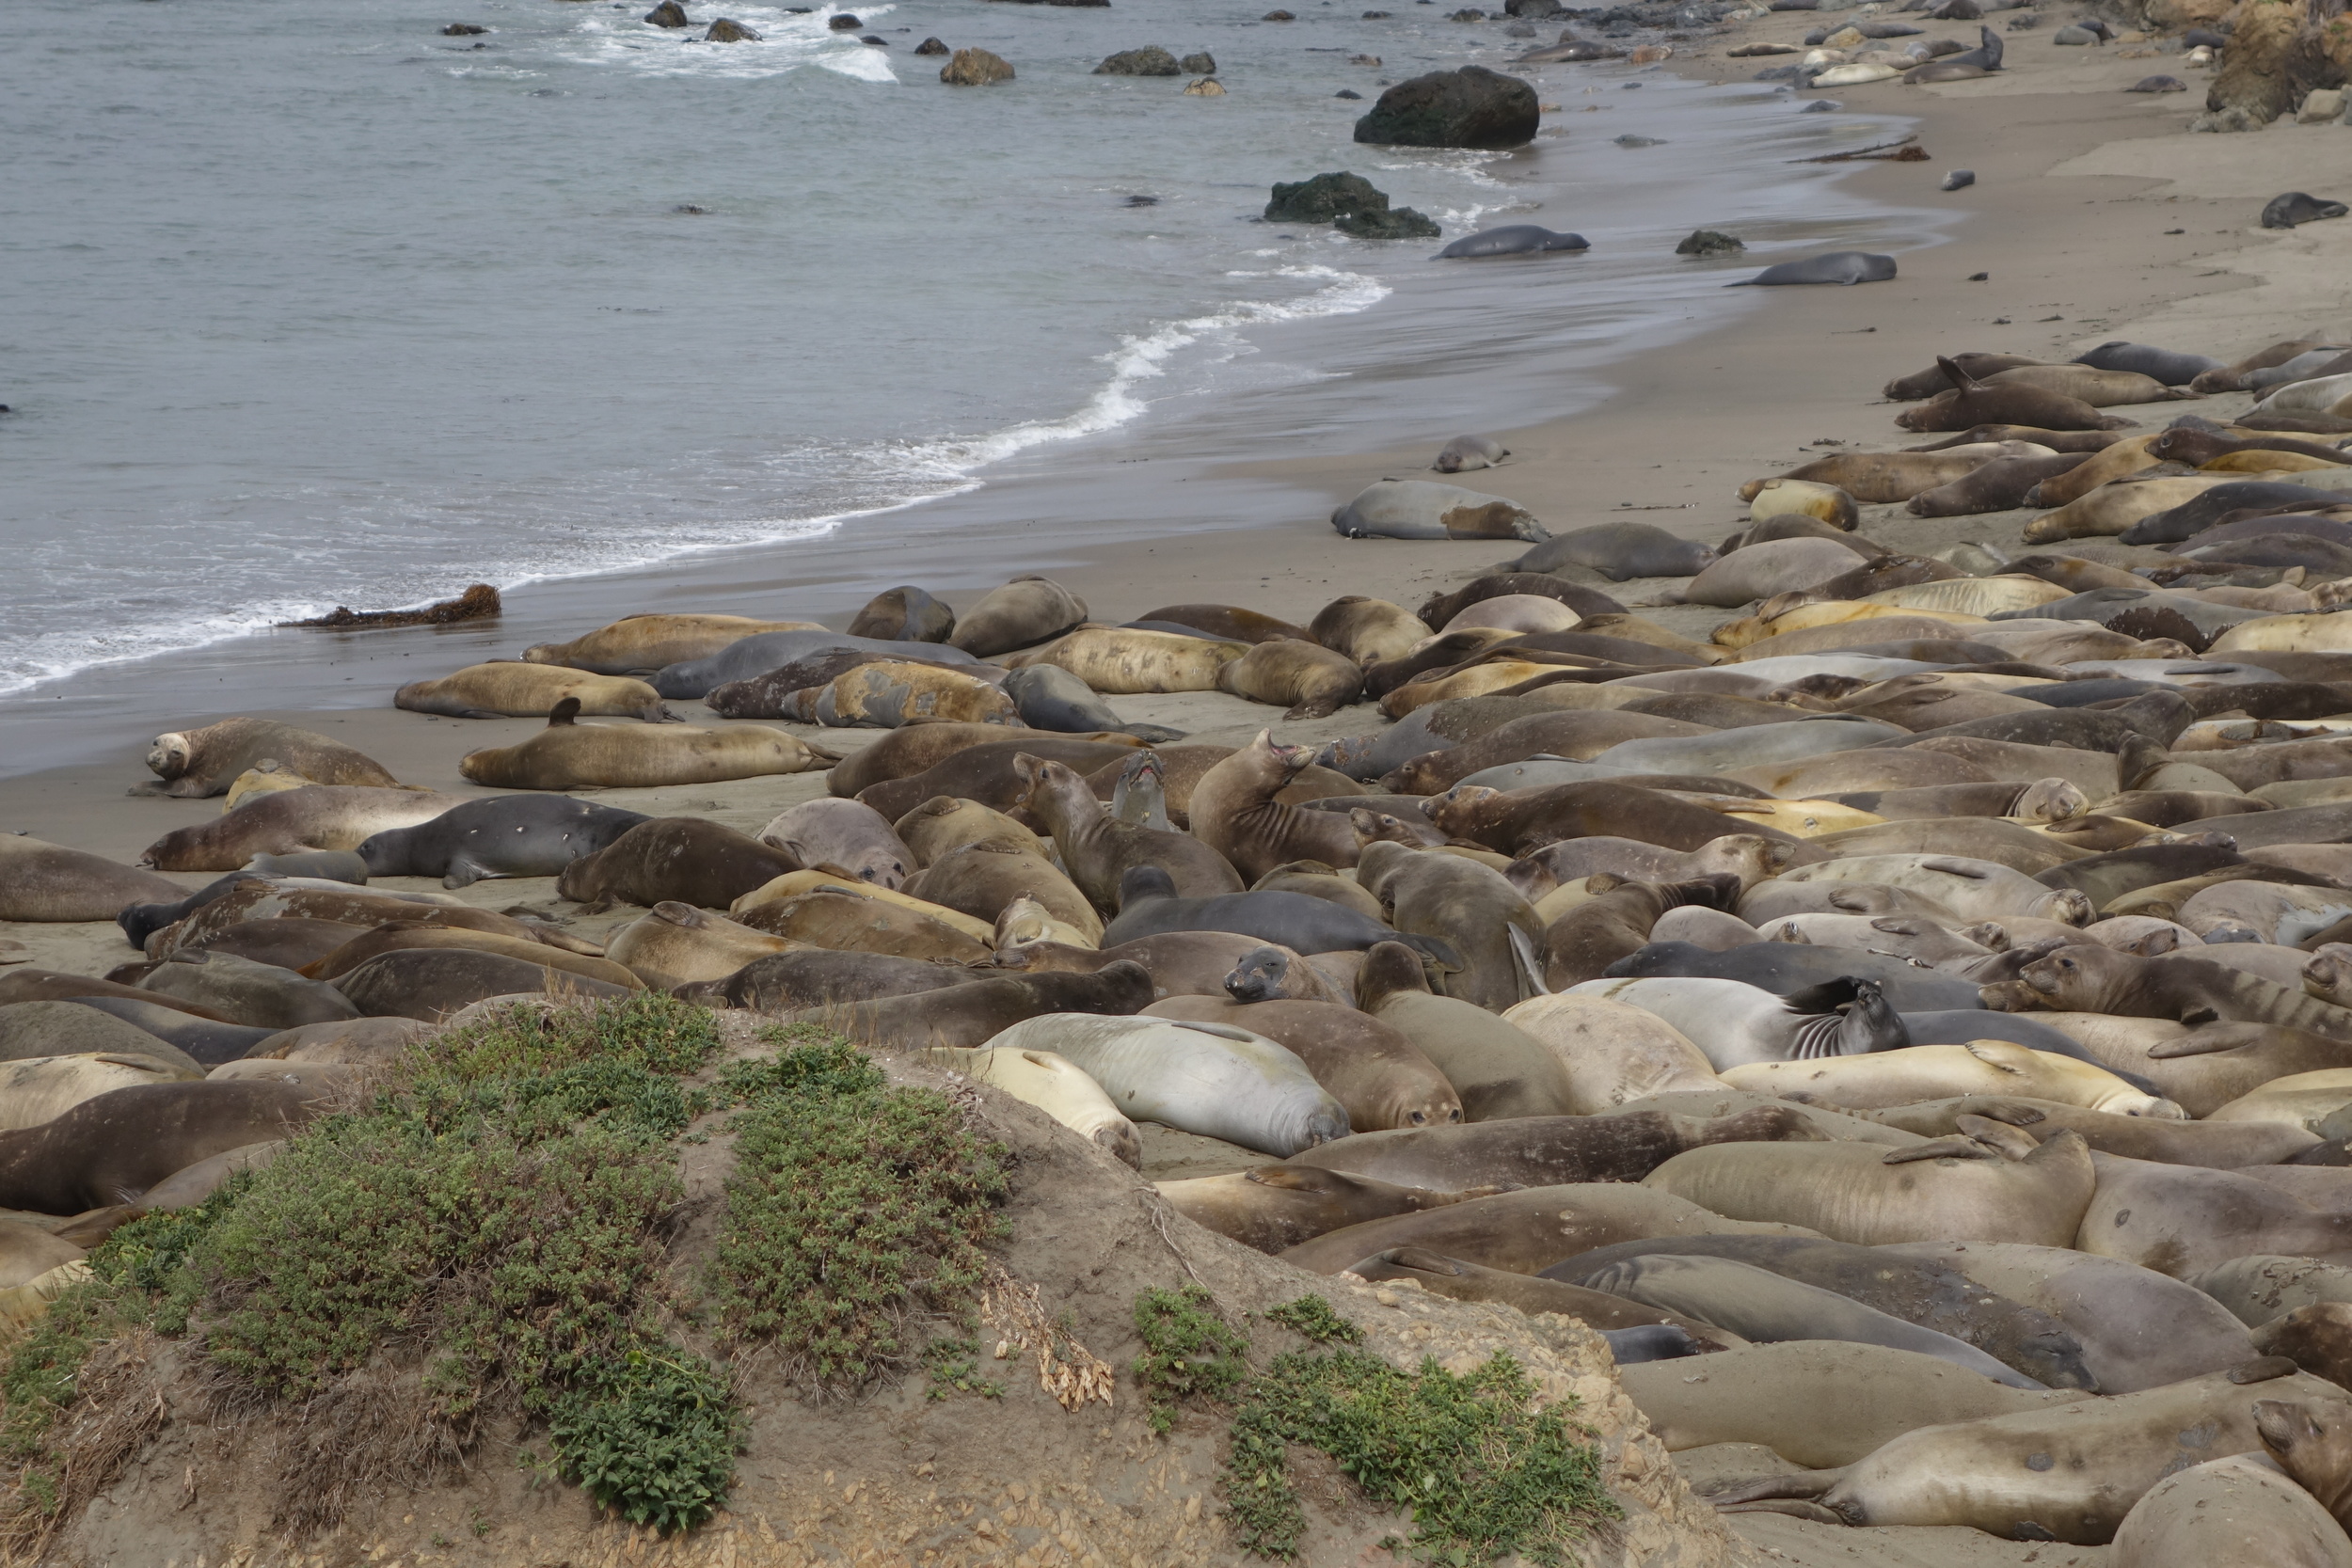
38, 1013, 1745, 1568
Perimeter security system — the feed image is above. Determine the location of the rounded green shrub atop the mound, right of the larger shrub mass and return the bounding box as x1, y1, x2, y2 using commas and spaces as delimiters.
706, 1039, 1007, 1397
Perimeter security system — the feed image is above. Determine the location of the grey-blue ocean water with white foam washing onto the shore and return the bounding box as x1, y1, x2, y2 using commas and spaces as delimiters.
0, 0, 1941, 771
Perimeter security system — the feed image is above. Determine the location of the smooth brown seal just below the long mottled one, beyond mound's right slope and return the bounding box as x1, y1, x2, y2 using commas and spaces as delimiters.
1282, 1184, 1816, 1275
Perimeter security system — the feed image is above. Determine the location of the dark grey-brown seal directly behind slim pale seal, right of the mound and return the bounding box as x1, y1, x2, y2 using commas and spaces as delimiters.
1546, 1237, 2098, 1389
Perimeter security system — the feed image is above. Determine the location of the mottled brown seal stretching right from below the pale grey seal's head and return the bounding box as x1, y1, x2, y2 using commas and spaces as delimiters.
1292, 1105, 1820, 1192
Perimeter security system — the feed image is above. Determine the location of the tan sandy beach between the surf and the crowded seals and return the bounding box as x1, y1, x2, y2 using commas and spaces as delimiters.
13, 9, 2352, 1568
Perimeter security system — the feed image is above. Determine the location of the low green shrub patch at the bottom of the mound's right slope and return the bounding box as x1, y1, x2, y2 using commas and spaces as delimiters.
1226, 1350, 1621, 1568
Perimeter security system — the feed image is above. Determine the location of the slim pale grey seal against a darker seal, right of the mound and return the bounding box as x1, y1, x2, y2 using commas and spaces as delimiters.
1569, 1243, 2044, 1389
